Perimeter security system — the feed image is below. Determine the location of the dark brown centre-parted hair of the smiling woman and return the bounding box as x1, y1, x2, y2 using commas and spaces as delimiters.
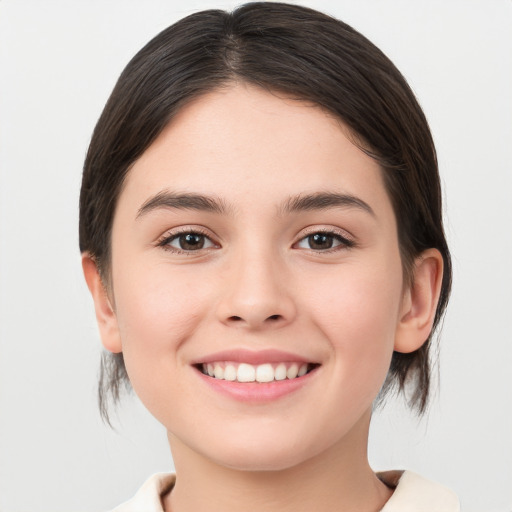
80, 2, 452, 421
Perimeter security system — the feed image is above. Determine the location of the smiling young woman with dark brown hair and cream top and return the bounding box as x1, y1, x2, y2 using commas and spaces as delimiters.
80, 3, 458, 512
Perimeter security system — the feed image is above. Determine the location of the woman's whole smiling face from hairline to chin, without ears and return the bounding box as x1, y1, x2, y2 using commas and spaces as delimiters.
110, 85, 404, 469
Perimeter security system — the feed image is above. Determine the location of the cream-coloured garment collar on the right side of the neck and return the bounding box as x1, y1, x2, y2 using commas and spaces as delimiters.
377, 471, 460, 512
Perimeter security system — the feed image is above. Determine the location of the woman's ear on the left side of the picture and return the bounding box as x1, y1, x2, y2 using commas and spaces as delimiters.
82, 253, 122, 353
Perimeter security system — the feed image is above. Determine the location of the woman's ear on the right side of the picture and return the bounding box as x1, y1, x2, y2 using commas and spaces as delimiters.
395, 249, 443, 353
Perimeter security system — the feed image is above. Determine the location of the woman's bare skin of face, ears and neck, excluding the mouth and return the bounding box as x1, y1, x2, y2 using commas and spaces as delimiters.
83, 84, 442, 512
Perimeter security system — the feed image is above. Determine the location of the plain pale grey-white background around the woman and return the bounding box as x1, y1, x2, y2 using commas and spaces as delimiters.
0, 0, 512, 512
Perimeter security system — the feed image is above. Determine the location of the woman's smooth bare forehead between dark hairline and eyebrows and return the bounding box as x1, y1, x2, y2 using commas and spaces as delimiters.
117, 84, 387, 220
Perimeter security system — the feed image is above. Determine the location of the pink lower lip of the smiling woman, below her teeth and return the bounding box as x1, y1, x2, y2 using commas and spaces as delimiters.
197, 368, 318, 403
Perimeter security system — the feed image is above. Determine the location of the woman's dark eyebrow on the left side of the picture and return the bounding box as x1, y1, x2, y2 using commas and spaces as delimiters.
136, 190, 228, 218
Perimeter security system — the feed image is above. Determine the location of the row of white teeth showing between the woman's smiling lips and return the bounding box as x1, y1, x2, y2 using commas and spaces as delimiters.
196, 361, 319, 383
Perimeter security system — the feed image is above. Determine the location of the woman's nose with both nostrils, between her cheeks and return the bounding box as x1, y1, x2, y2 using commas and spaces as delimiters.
217, 247, 297, 330
